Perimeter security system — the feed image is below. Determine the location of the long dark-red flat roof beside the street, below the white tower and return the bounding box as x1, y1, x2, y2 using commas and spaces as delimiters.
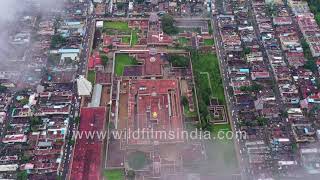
70, 107, 106, 180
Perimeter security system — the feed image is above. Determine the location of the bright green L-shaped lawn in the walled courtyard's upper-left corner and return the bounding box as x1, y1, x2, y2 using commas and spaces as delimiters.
115, 54, 137, 76
